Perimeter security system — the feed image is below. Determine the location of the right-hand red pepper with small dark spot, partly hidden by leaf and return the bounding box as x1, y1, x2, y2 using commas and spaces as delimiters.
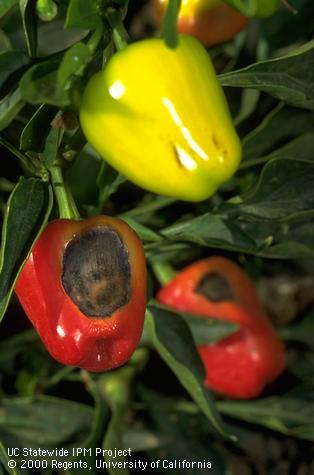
157, 257, 285, 399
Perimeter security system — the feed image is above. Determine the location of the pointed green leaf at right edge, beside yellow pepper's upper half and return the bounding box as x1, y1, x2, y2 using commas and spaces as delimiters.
219, 41, 314, 109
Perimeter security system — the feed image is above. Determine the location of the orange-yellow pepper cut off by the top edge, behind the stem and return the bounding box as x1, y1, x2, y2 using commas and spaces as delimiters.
152, 0, 249, 46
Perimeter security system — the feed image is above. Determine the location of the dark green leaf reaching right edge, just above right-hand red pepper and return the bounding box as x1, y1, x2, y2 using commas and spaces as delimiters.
161, 213, 314, 260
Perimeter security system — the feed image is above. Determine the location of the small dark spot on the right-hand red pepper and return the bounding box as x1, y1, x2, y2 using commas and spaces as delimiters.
195, 272, 235, 302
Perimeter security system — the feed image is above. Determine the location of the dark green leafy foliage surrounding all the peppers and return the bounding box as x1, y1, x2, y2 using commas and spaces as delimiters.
0, 0, 314, 474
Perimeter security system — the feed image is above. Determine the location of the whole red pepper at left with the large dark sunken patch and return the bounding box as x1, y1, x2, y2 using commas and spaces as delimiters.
15, 216, 146, 372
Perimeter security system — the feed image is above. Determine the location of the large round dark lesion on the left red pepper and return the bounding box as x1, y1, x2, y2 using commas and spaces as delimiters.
62, 226, 131, 317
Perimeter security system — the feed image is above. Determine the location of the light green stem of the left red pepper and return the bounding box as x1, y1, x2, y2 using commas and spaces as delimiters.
49, 163, 80, 219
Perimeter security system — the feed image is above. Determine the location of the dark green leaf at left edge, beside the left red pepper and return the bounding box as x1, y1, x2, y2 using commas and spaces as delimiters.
0, 177, 52, 320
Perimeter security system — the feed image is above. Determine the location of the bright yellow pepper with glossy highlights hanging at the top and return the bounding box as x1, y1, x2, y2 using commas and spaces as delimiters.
80, 35, 241, 201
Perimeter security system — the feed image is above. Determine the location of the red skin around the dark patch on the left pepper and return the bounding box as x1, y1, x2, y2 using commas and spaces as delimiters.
15, 216, 146, 372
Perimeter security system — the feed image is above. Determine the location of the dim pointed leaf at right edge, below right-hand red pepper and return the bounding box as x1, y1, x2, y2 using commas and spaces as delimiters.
217, 387, 314, 441
